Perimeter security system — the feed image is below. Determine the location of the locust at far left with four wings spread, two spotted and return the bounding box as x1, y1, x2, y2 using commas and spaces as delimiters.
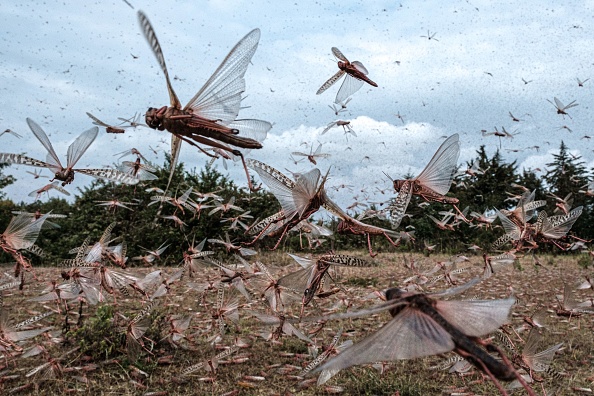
0, 118, 138, 186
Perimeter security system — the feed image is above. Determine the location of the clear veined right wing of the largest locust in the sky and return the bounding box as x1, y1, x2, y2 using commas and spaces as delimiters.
184, 29, 260, 125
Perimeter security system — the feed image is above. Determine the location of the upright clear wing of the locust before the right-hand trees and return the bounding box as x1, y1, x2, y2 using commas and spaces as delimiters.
415, 133, 460, 195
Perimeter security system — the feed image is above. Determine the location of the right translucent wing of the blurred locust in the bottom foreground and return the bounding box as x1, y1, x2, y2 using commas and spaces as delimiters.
435, 297, 516, 337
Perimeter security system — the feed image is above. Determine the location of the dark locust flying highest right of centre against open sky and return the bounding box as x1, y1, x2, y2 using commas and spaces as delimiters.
316, 47, 377, 106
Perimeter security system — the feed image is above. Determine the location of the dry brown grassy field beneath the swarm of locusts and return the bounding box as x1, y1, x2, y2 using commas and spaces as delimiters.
0, 252, 594, 395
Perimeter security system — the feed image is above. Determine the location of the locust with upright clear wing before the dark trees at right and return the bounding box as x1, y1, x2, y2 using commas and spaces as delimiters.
389, 133, 463, 229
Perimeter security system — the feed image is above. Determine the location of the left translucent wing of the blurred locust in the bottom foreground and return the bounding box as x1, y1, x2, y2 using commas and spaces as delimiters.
315, 307, 455, 372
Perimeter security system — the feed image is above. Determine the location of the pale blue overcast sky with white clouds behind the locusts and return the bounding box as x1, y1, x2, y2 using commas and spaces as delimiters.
0, 0, 594, 213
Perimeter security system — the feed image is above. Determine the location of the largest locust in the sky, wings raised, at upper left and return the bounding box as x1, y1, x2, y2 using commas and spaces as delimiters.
138, 11, 272, 189
